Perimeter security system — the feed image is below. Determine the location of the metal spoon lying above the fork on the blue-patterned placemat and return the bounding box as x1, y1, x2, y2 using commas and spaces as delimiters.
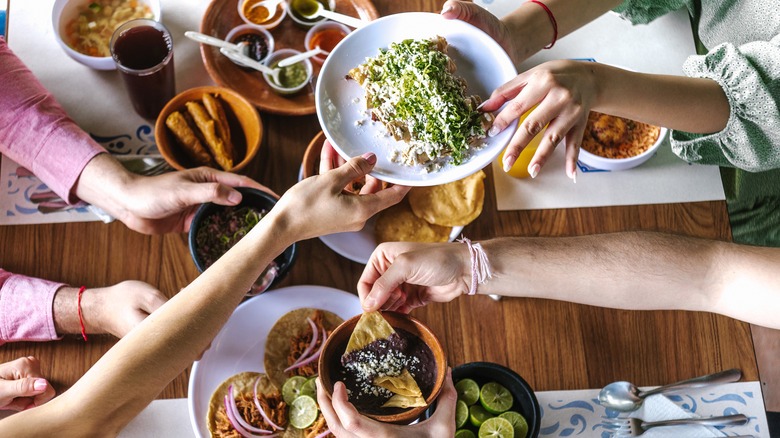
599, 368, 742, 412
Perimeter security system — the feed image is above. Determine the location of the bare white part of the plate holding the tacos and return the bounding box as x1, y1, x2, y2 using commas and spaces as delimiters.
187, 286, 362, 438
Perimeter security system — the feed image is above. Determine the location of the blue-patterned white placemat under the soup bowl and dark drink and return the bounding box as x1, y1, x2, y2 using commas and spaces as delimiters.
0, 0, 212, 225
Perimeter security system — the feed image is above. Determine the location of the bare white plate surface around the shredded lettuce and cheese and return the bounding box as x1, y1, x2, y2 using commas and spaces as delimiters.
315, 12, 517, 186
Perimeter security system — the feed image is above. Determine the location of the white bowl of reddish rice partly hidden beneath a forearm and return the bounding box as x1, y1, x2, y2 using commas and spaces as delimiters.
579, 111, 668, 170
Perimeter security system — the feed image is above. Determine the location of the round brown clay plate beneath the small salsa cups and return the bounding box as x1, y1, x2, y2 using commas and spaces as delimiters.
200, 0, 379, 116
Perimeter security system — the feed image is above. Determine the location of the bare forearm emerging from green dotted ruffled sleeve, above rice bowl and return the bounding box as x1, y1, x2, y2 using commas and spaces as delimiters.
584, 63, 730, 134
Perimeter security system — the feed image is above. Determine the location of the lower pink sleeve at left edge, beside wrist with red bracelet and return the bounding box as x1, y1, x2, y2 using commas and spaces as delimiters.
0, 269, 64, 344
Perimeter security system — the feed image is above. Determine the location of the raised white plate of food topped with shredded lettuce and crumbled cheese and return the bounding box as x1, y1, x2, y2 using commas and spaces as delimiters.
316, 12, 517, 186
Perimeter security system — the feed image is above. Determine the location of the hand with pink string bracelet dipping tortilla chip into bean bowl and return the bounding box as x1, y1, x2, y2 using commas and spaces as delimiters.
358, 242, 471, 313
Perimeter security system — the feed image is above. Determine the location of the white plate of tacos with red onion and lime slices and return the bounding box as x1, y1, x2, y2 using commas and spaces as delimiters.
187, 286, 362, 438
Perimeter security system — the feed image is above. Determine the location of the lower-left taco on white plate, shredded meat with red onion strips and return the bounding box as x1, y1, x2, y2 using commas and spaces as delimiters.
207, 372, 304, 438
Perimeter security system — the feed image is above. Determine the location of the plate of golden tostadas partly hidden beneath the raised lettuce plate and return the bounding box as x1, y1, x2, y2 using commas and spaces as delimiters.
298, 132, 485, 264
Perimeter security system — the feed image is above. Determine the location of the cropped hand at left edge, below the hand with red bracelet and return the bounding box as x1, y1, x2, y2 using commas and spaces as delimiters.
0, 356, 54, 411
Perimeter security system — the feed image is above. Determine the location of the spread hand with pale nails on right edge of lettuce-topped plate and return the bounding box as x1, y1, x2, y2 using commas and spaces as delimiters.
482, 61, 599, 181
